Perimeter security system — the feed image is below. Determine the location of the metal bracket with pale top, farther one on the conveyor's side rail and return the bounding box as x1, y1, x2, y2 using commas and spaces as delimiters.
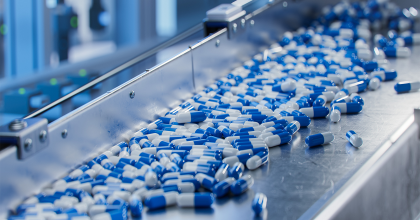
204, 4, 247, 39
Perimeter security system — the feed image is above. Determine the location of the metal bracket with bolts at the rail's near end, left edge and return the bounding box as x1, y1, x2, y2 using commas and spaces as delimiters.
0, 118, 49, 160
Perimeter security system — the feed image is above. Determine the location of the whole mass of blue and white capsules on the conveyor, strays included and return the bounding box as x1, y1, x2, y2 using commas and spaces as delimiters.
10, 1, 419, 219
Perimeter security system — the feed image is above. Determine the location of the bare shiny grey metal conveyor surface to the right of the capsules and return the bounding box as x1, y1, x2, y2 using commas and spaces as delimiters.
139, 46, 420, 220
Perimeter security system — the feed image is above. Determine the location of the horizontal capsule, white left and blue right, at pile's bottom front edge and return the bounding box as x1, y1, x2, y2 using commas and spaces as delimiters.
177, 193, 214, 208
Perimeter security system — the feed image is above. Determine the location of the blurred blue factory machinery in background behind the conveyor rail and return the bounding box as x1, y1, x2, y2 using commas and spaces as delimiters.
0, 0, 240, 124
